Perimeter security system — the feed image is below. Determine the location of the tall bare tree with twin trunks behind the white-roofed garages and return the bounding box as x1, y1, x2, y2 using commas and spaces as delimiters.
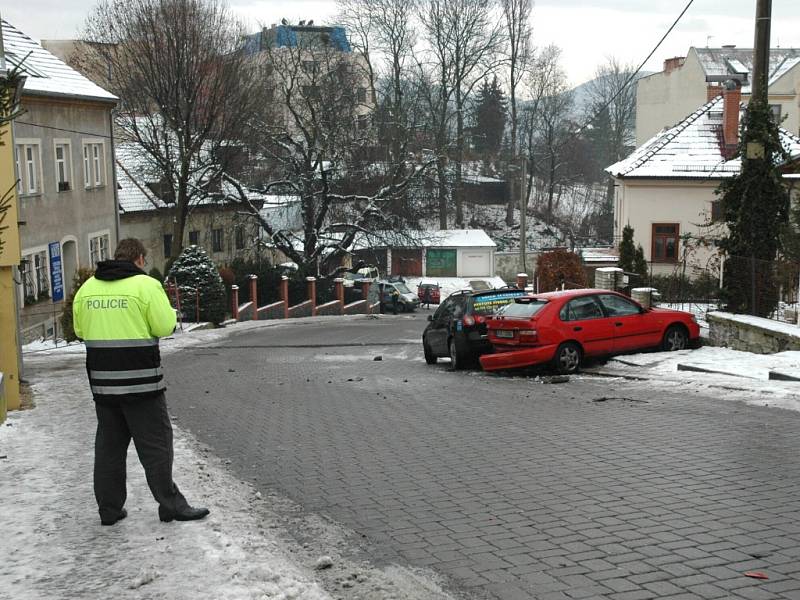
420, 0, 503, 227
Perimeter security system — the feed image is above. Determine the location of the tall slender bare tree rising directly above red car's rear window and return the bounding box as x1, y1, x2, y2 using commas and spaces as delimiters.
500, 0, 534, 225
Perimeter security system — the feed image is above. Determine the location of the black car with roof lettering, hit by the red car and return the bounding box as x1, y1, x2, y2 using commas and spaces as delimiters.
422, 288, 525, 369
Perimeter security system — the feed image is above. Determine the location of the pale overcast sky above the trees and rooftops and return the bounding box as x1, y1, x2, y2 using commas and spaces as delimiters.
6, 0, 800, 84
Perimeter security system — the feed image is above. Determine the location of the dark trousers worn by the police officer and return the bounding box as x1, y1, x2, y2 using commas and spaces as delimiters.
94, 394, 188, 520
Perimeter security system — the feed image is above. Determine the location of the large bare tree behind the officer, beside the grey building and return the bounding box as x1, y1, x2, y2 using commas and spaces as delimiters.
85, 0, 256, 257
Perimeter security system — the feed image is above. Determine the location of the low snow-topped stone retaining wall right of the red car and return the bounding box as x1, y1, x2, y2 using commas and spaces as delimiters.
706, 312, 800, 354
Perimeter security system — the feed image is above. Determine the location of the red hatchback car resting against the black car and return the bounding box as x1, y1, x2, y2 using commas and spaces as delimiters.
480, 290, 700, 373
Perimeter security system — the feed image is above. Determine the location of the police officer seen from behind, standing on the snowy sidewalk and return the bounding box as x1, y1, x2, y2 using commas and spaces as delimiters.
73, 238, 209, 525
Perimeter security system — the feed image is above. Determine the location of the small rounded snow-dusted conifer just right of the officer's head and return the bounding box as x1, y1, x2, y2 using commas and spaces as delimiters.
167, 246, 226, 324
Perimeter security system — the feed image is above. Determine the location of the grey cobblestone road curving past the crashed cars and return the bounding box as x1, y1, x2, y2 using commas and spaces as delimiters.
166, 316, 800, 600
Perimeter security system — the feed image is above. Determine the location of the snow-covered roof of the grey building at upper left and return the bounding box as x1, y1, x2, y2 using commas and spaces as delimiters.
0, 19, 118, 103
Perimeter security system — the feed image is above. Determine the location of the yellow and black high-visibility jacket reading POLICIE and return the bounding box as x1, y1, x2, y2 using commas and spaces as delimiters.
72, 260, 176, 401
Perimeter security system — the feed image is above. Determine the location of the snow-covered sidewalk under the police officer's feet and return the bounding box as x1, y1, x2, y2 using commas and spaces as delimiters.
0, 323, 460, 600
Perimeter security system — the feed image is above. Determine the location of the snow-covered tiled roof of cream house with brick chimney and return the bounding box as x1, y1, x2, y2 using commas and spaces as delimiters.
606, 97, 800, 179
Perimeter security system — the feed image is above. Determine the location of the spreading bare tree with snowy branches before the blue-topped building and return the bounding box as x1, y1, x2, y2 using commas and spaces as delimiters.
229, 30, 432, 274
